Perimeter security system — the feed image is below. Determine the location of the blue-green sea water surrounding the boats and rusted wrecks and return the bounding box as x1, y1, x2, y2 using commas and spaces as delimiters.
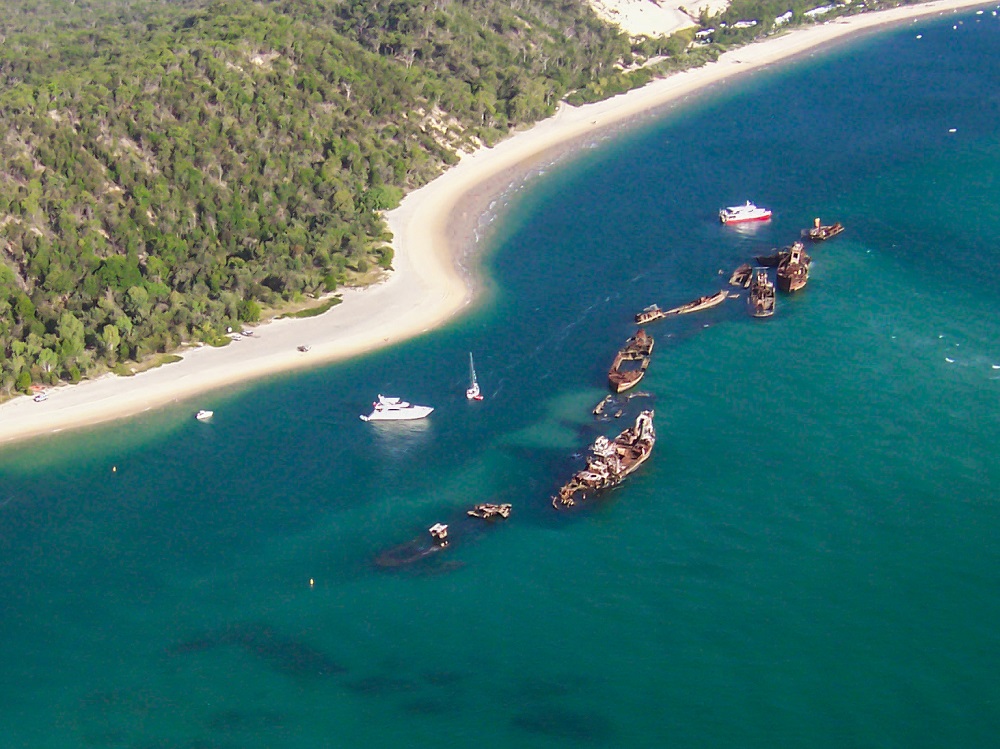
0, 9, 1000, 749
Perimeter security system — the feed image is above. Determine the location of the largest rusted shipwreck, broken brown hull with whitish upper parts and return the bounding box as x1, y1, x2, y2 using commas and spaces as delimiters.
552, 410, 656, 510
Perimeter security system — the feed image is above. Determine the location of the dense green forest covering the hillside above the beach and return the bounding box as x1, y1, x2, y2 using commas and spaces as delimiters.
0, 0, 916, 395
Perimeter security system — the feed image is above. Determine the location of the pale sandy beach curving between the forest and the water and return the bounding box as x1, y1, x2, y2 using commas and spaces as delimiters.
0, 0, 992, 443
